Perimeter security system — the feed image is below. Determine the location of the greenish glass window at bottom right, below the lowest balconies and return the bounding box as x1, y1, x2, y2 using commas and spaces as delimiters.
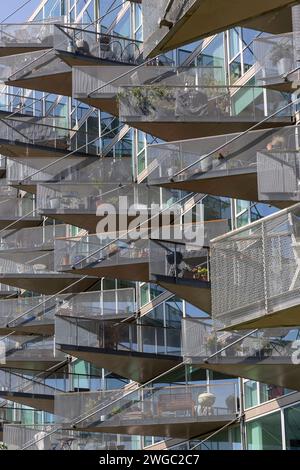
246, 412, 282, 450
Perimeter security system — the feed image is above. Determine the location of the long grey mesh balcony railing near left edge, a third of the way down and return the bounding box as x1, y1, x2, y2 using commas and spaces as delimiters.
6, 155, 132, 184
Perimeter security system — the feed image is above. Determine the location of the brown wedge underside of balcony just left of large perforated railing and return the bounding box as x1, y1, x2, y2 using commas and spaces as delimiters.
156, 276, 211, 313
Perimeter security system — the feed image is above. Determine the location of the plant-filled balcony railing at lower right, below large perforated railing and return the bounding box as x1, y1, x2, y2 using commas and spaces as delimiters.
182, 318, 299, 365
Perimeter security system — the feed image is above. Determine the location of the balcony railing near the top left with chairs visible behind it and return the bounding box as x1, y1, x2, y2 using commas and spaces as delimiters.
54, 25, 143, 65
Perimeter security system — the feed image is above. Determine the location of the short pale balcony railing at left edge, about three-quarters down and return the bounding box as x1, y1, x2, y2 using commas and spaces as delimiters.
0, 336, 65, 367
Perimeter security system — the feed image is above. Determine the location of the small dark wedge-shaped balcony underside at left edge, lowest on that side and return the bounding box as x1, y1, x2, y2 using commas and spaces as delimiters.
0, 390, 54, 413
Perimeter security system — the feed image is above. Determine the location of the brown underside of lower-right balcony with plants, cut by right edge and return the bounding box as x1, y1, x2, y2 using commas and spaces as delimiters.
192, 357, 300, 391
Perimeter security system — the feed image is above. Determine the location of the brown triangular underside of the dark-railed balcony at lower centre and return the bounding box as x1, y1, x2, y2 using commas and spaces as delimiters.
59, 344, 182, 383
